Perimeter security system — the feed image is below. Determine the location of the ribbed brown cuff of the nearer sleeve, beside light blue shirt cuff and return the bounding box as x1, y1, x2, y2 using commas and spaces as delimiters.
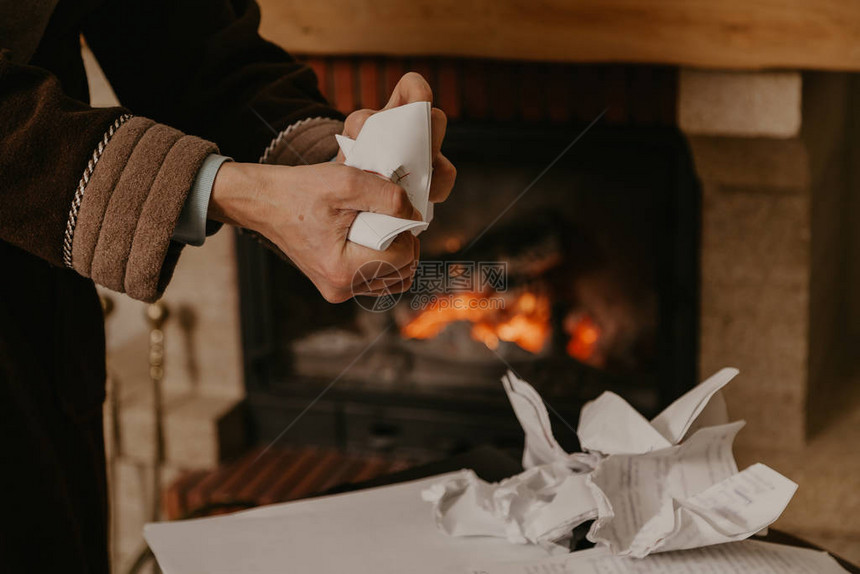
72, 118, 218, 301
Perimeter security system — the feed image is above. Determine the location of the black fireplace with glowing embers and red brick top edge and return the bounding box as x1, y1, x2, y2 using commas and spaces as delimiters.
237, 58, 701, 456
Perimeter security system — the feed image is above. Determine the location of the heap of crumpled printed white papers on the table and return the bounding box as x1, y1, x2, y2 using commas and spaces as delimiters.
422, 368, 797, 557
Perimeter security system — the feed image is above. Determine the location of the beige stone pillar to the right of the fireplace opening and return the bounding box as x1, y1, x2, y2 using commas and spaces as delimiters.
677, 70, 849, 450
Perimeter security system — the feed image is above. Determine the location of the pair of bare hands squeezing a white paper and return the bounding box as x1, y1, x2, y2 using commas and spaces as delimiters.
208, 73, 456, 303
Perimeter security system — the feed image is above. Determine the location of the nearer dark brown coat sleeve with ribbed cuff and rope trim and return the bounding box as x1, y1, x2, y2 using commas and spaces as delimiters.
0, 52, 217, 301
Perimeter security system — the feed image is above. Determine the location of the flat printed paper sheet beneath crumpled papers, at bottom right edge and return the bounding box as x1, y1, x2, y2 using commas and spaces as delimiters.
469, 540, 847, 574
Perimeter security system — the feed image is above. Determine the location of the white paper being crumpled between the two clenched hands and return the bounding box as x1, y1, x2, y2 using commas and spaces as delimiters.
336, 102, 433, 251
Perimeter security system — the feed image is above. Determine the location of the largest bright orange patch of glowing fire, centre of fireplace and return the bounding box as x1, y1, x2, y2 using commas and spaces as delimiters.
401, 291, 551, 353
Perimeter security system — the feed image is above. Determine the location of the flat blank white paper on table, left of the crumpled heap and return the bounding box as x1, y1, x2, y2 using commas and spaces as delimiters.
144, 472, 548, 574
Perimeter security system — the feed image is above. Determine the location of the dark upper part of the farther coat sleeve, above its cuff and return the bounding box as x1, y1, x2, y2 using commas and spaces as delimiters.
84, 0, 342, 163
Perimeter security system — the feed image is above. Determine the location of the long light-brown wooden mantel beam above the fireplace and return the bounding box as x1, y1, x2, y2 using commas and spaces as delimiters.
260, 0, 860, 70
